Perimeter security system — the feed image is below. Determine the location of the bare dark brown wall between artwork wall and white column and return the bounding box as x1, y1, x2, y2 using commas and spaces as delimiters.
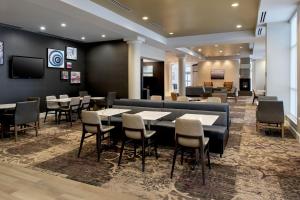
86, 40, 128, 98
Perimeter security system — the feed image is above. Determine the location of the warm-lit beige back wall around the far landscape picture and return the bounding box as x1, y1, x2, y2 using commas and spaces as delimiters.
198, 60, 240, 88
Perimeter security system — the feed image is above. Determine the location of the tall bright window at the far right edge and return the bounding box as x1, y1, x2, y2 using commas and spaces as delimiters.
290, 13, 297, 119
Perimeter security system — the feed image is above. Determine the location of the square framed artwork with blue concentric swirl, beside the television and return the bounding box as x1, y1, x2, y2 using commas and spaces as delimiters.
48, 49, 65, 69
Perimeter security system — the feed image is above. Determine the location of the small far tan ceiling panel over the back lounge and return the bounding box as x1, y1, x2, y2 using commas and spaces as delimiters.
193, 43, 250, 57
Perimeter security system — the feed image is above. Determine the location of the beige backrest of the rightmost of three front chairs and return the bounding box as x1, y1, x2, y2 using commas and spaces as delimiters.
175, 119, 204, 147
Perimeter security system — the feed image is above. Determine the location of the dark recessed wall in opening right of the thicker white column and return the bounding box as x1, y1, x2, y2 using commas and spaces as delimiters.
141, 62, 165, 98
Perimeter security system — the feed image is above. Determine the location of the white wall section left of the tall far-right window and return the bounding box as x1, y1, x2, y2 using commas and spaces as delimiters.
266, 22, 290, 113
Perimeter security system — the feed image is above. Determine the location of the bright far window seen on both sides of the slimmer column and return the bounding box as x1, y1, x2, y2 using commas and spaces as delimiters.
171, 64, 192, 92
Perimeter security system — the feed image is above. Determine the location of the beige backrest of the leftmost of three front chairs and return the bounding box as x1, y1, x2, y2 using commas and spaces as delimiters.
81, 111, 102, 133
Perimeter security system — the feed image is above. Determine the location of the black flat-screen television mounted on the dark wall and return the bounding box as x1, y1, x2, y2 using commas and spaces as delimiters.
11, 56, 44, 79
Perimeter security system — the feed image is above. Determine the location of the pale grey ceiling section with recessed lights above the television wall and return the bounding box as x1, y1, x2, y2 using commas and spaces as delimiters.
0, 0, 123, 42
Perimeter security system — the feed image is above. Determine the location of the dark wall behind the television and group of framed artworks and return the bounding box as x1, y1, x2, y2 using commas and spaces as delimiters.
0, 26, 85, 106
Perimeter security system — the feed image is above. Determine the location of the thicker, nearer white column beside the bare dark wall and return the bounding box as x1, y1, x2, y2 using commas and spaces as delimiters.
127, 39, 144, 99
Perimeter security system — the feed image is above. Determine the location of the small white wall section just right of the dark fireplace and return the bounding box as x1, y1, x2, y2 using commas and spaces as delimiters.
252, 59, 266, 90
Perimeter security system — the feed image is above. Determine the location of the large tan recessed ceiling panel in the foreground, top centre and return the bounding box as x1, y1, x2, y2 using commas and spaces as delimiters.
92, 0, 259, 37
